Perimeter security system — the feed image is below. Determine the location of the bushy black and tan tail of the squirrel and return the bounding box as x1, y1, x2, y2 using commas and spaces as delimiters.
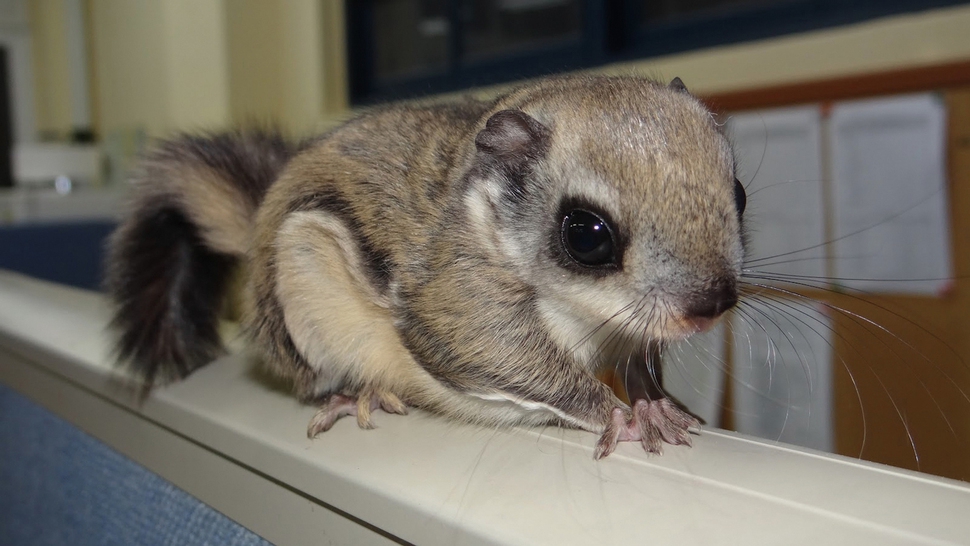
106, 132, 295, 393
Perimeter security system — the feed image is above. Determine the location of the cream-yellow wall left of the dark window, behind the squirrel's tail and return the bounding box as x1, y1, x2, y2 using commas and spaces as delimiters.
29, 0, 347, 137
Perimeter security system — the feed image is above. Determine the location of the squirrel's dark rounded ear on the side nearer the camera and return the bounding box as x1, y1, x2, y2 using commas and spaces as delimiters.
475, 110, 549, 170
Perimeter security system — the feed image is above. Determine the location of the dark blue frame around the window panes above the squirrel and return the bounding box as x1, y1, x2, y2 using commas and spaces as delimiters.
345, 0, 968, 105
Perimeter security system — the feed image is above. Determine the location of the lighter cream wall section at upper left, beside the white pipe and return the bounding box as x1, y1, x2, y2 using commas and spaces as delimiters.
90, 0, 229, 134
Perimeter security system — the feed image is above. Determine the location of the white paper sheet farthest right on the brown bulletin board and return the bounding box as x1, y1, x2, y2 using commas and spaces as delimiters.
830, 94, 952, 294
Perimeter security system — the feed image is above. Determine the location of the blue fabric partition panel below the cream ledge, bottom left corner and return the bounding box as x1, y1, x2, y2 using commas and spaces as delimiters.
0, 384, 268, 546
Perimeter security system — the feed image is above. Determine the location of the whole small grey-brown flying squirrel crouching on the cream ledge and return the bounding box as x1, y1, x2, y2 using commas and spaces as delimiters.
108, 72, 745, 458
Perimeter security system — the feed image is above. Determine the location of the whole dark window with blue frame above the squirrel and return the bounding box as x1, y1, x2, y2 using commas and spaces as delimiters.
345, 0, 968, 104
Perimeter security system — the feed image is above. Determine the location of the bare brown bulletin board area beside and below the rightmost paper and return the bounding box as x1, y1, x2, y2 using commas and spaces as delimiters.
824, 88, 970, 480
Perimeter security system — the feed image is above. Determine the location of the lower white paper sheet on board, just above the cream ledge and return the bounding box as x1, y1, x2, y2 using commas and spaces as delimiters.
730, 298, 834, 451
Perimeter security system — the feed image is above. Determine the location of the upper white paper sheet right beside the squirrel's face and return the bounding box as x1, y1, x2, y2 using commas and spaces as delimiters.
727, 106, 825, 279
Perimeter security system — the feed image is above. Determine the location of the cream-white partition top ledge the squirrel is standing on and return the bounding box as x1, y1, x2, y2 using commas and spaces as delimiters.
0, 272, 970, 544
